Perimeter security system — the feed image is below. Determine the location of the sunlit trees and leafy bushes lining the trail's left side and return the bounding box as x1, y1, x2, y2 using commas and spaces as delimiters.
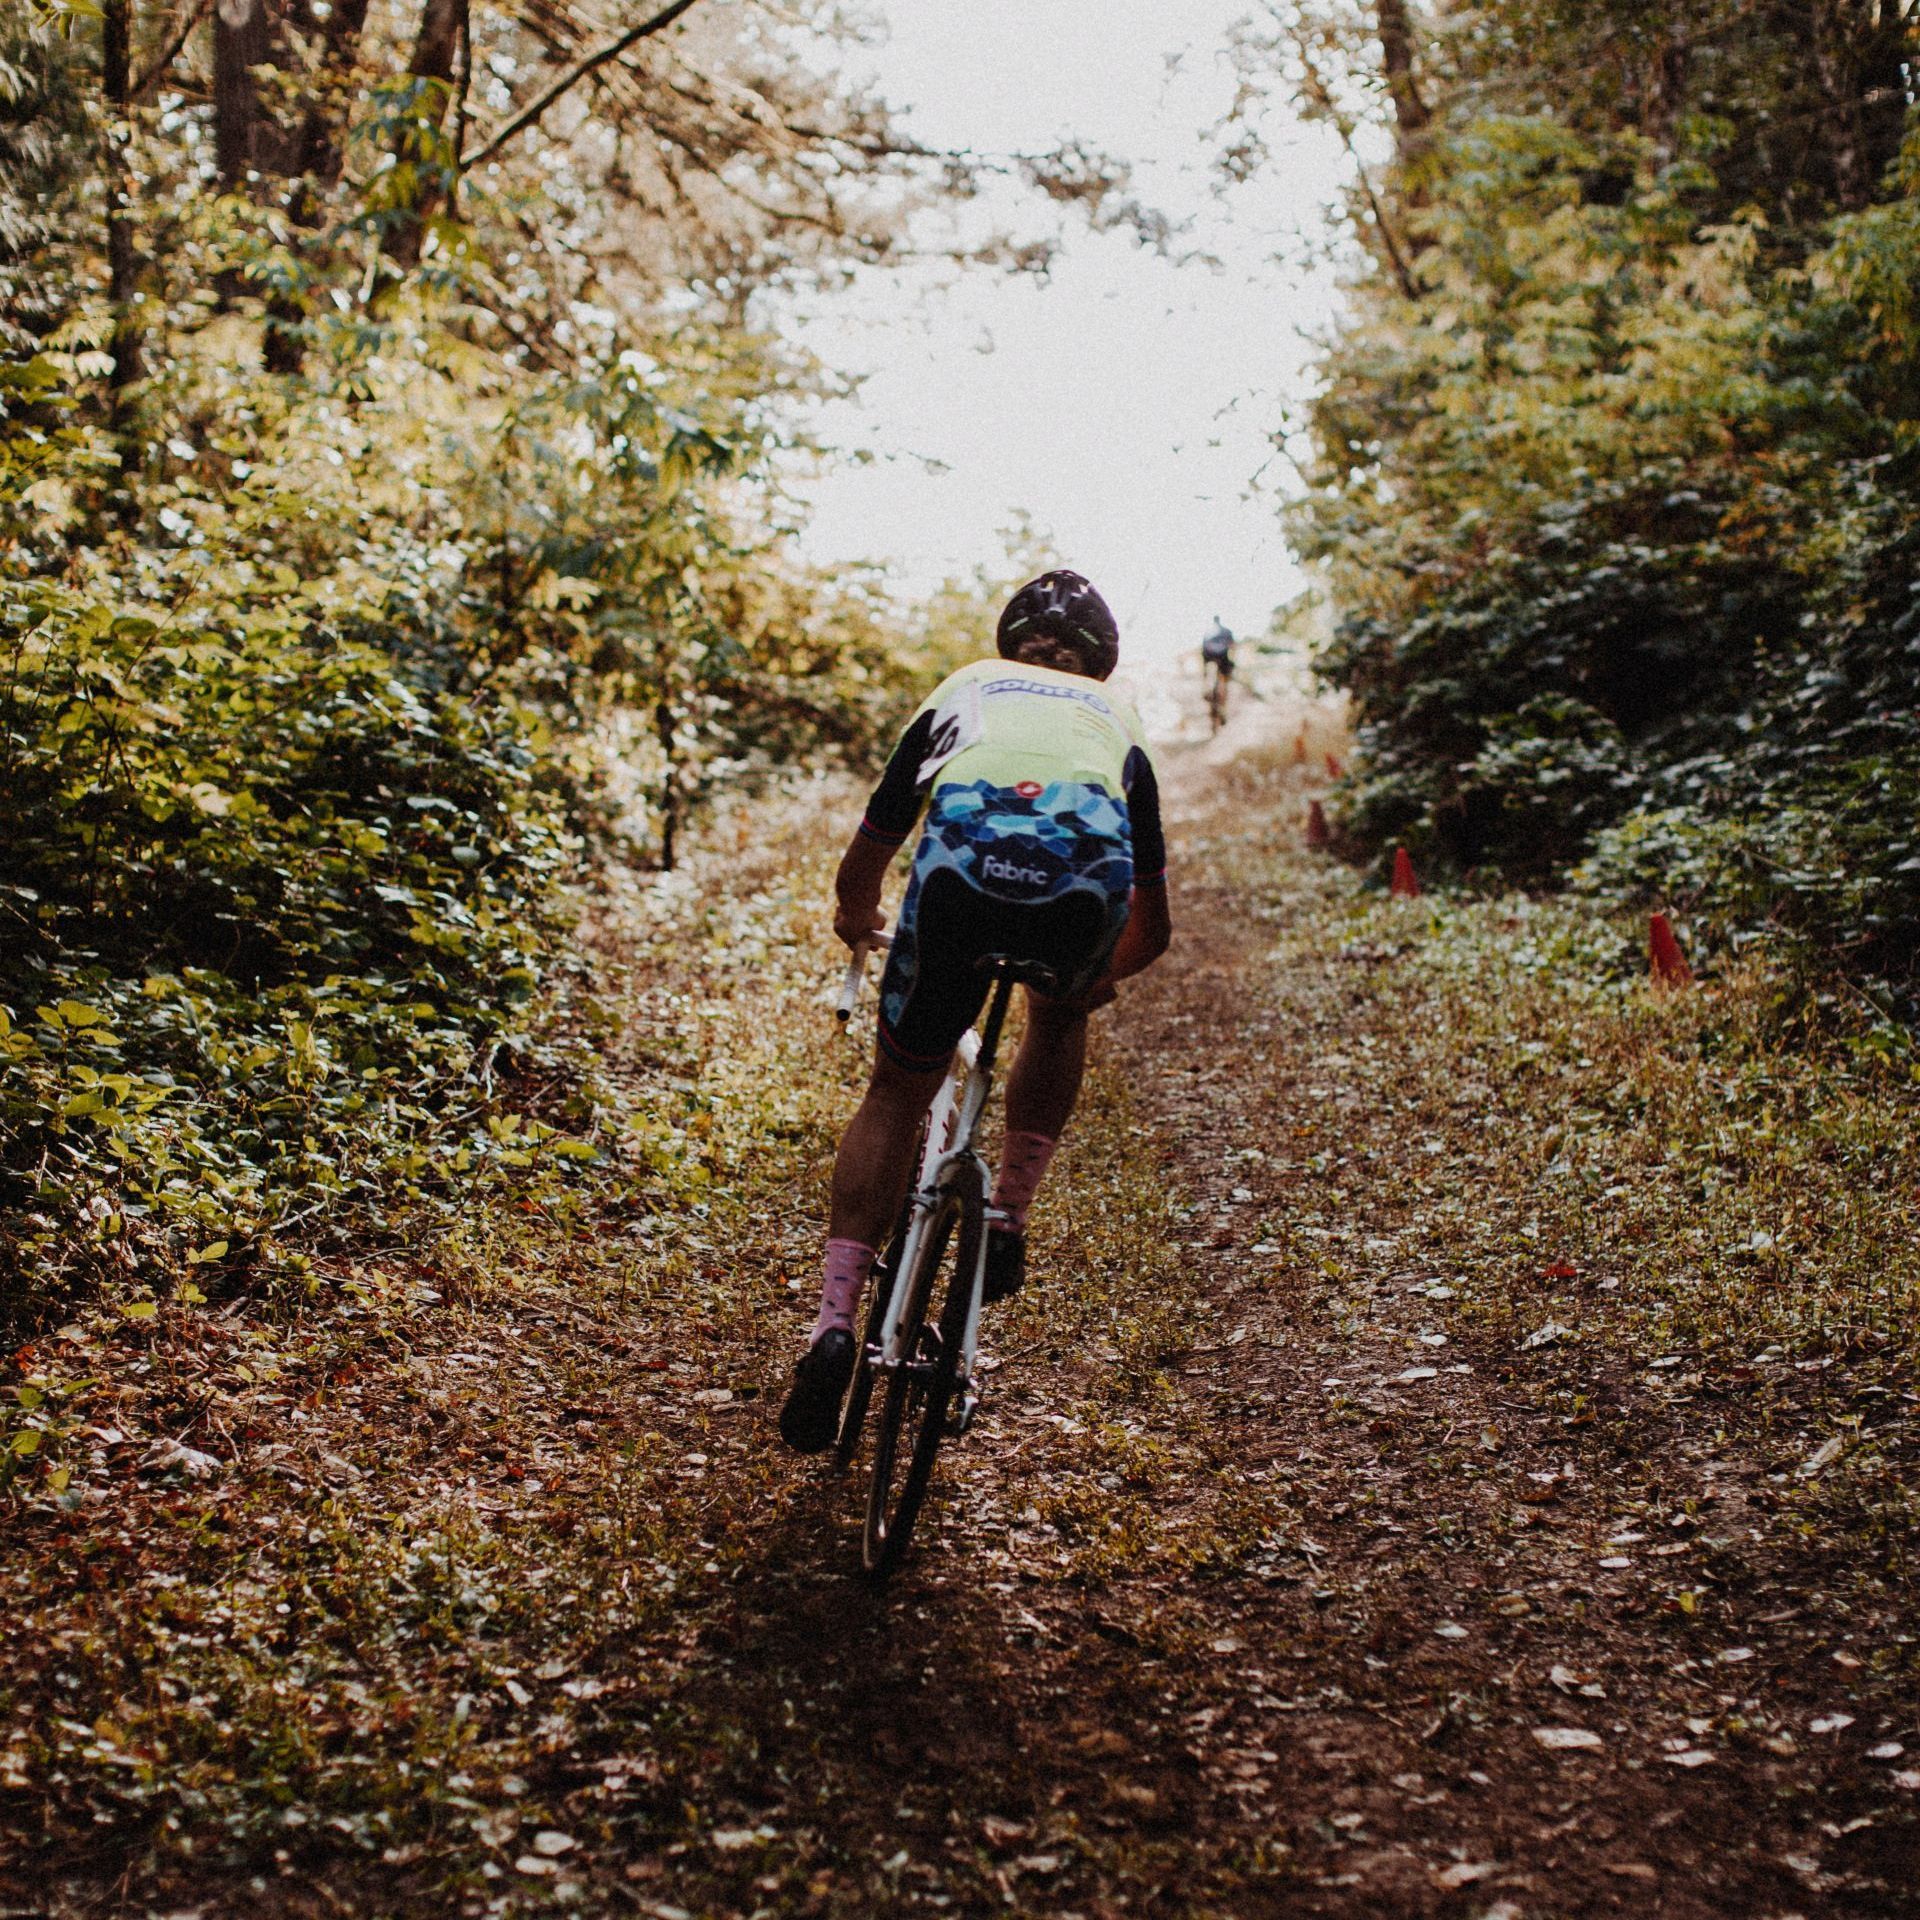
0, 0, 1113, 1321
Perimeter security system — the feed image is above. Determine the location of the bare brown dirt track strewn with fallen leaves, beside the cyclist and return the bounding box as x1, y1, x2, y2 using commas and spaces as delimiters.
664, 737, 1916, 1916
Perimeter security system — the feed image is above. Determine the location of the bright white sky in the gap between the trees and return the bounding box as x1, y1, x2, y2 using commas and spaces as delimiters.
775, 0, 1346, 664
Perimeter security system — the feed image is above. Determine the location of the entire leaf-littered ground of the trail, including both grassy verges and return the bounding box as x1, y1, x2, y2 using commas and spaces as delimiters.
0, 747, 1920, 1920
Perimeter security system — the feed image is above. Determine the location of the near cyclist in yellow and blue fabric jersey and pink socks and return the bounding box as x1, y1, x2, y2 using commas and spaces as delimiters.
780, 570, 1171, 1453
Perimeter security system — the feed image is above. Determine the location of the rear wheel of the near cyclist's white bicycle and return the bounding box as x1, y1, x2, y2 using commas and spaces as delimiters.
862, 1158, 987, 1580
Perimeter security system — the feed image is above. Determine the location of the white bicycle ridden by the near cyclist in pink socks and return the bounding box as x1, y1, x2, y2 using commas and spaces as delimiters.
833, 933, 1062, 1582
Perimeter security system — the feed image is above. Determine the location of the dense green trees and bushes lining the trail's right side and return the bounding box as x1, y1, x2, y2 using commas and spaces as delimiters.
1233, 0, 1920, 1014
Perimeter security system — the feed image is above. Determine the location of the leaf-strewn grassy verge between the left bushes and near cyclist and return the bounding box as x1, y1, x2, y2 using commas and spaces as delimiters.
0, 783, 851, 1905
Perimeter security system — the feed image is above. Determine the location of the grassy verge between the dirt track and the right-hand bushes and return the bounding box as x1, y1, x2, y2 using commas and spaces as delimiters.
1212, 741, 1920, 1580
